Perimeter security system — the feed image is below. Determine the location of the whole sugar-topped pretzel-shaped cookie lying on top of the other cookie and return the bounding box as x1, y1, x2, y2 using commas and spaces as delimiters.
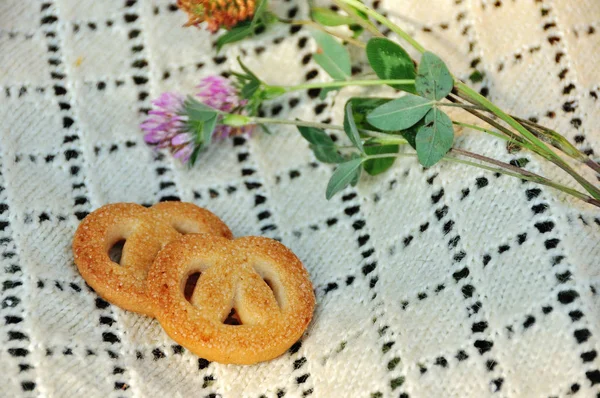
147, 235, 315, 364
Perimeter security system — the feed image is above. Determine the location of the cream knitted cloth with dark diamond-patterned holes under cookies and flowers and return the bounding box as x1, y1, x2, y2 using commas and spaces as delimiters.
0, 0, 600, 398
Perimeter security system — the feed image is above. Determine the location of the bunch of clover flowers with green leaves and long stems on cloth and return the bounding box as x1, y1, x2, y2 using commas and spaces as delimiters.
142, 0, 600, 207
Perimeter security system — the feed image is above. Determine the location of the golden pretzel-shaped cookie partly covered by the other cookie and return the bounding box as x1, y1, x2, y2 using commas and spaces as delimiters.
73, 202, 232, 316
